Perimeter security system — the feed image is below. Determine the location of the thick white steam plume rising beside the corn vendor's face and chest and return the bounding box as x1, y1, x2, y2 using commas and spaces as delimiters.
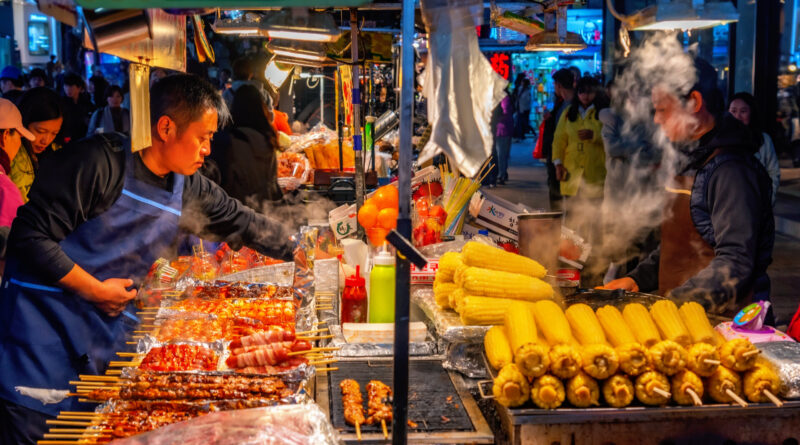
588, 33, 697, 273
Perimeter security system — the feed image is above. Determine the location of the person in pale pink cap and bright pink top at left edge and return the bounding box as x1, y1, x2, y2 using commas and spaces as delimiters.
0, 99, 35, 258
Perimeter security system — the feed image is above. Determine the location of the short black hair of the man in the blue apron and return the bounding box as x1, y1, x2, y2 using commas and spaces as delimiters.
150, 73, 230, 133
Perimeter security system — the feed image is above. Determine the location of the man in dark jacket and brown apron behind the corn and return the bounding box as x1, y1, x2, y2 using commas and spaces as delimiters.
606, 60, 775, 315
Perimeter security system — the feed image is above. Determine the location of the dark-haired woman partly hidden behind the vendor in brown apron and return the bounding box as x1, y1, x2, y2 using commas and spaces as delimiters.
728, 92, 781, 207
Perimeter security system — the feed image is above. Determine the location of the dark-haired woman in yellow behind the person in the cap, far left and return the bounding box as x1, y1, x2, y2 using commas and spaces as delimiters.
9, 87, 64, 202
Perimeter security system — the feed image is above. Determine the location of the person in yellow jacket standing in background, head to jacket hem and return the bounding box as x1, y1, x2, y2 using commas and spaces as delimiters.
553, 77, 606, 199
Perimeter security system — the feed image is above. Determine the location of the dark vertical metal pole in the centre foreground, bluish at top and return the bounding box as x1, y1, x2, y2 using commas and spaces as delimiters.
392, 0, 415, 445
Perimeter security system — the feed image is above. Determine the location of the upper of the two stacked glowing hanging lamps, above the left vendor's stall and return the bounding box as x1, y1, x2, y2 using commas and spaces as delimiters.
261, 8, 342, 42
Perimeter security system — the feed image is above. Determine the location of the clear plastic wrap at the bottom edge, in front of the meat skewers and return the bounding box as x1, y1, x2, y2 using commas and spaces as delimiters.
108, 404, 341, 445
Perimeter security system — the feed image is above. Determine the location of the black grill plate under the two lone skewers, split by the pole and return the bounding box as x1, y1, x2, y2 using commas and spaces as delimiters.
330, 360, 474, 433
